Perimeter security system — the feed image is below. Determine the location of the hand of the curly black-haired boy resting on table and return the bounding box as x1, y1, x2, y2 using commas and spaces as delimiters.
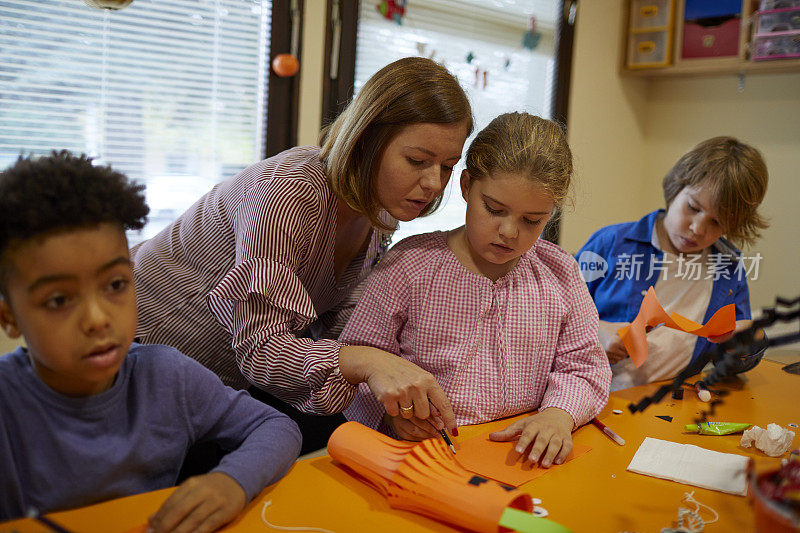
148, 472, 247, 533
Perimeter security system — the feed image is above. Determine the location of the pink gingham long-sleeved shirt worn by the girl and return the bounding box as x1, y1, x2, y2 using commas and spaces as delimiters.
340, 231, 611, 433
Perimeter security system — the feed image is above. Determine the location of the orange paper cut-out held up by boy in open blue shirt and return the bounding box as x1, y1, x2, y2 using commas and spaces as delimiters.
617, 287, 736, 368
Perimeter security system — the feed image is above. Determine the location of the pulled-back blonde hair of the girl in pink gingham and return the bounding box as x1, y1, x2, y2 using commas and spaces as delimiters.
467, 113, 572, 207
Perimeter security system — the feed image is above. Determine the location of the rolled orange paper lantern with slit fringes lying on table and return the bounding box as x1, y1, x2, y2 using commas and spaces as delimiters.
328, 422, 533, 533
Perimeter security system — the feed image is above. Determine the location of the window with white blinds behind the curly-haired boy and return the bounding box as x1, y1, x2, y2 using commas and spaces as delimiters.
0, 0, 272, 243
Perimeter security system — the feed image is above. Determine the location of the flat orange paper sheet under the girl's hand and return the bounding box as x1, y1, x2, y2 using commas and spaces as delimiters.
456, 433, 591, 487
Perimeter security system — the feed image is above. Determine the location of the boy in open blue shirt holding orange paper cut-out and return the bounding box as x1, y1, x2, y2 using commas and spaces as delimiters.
576, 137, 767, 391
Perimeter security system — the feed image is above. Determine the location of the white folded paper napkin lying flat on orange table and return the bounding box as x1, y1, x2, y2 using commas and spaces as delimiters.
628, 437, 748, 496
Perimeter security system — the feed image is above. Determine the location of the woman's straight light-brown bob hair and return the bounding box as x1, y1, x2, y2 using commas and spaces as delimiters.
320, 57, 472, 230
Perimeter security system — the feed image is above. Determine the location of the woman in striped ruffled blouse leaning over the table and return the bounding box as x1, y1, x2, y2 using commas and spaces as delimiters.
132, 58, 472, 451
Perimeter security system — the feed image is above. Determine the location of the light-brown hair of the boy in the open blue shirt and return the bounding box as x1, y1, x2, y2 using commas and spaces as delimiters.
662, 137, 769, 245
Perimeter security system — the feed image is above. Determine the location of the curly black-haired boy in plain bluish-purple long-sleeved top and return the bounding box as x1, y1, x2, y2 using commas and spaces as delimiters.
0, 151, 300, 531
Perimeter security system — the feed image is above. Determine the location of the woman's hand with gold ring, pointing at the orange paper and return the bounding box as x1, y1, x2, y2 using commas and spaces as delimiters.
339, 346, 456, 430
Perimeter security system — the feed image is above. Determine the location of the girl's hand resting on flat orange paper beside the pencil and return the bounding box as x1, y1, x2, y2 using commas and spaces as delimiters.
489, 407, 575, 468
